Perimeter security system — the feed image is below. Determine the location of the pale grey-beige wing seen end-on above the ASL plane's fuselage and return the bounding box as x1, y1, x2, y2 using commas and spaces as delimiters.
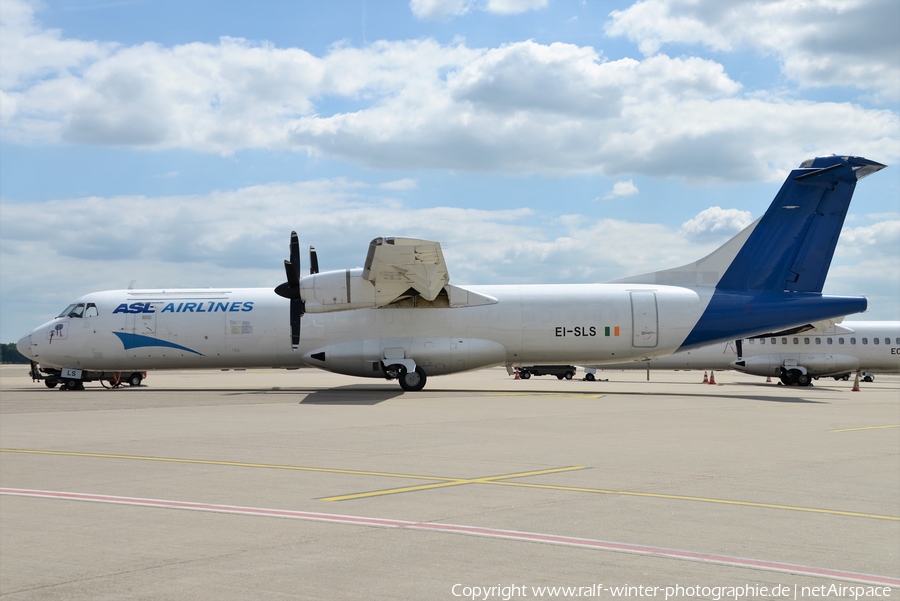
362, 238, 450, 305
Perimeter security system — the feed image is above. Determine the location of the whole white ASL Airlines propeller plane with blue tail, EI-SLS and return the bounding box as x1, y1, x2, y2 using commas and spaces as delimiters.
17, 156, 885, 391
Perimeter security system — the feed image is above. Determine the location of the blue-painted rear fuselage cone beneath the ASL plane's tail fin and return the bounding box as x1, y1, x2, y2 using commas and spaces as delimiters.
678, 290, 868, 351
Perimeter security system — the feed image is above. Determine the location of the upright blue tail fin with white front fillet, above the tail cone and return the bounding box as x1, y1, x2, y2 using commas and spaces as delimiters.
615, 156, 885, 293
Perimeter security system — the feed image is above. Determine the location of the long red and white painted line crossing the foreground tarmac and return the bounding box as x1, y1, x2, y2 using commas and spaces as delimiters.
0, 488, 900, 588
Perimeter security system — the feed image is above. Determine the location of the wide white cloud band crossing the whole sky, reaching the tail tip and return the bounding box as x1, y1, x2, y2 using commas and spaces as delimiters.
0, 4, 900, 180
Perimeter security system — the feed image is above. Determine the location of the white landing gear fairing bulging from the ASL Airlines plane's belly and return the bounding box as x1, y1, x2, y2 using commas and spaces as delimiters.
303, 338, 506, 378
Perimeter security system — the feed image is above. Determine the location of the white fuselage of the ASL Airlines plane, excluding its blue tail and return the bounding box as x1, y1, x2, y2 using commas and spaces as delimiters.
19, 284, 712, 377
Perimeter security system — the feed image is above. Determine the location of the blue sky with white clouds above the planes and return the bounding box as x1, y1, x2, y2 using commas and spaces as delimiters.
0, 0, 900, 342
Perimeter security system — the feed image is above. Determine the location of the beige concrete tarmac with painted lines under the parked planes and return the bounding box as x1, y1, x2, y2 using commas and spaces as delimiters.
0, 365, 900, 600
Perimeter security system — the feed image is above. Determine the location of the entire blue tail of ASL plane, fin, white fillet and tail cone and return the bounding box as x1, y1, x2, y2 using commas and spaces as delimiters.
615, 156, 884, 350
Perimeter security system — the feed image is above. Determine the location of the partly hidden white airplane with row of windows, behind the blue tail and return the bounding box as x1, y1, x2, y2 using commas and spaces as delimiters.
585, 321, 900, 386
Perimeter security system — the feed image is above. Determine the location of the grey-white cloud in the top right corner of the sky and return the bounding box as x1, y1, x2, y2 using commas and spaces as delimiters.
606, 0, 900, 101
